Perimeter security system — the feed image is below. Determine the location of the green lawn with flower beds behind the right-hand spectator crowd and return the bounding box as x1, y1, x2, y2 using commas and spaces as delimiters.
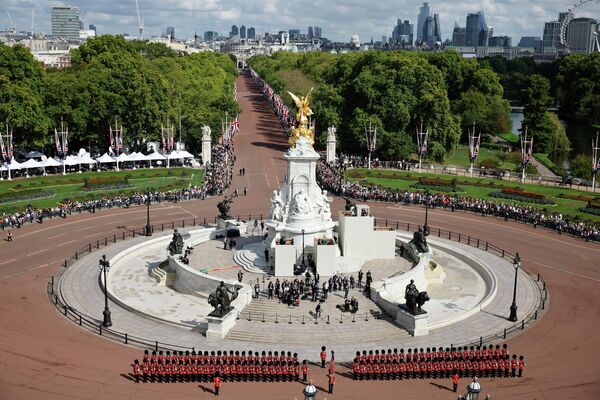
346, 169, 600, 222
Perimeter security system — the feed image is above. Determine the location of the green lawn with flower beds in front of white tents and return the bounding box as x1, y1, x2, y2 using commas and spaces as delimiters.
0, 168, 204, 213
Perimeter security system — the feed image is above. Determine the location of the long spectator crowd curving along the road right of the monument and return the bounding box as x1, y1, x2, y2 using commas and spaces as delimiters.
317, 162, 600, 241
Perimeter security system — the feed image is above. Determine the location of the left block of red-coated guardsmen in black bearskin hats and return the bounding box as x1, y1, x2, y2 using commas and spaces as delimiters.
131, 350, 308, 383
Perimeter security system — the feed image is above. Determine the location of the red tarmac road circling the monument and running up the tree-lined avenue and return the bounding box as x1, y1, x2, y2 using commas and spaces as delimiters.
0, 77, 600, 399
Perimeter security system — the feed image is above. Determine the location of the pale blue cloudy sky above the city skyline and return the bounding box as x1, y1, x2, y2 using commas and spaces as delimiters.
0, 0, 600, 45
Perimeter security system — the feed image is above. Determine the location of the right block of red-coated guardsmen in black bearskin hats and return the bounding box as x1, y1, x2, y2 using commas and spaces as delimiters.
352, 344, 525, 380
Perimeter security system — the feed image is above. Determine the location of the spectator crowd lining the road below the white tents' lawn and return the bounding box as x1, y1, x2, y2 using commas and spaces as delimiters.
0, 146, 234, 229
